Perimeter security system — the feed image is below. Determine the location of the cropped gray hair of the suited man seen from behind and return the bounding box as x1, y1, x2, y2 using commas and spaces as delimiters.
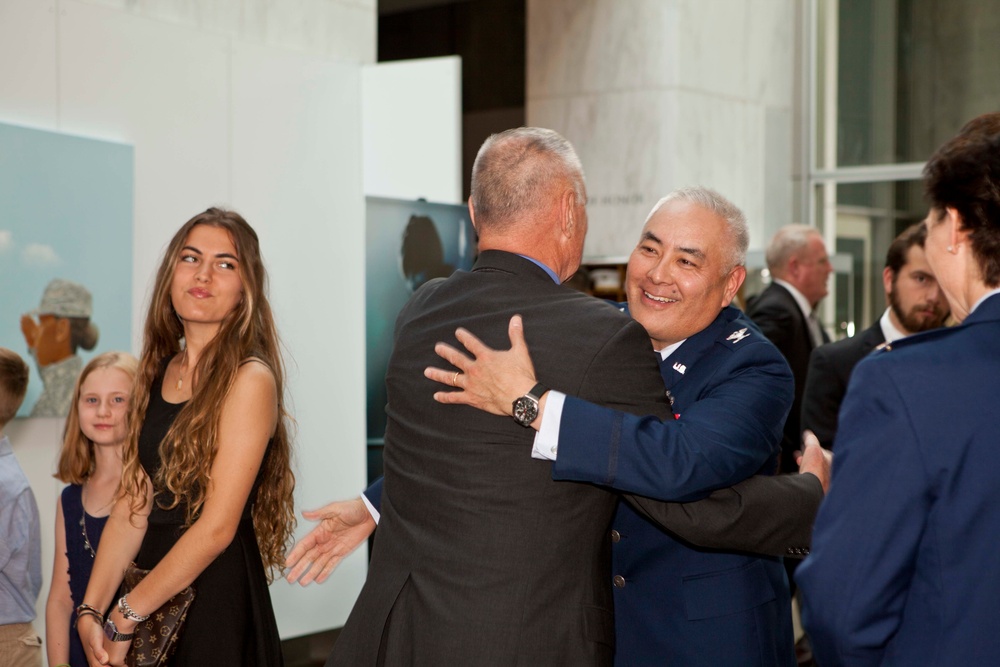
471, 127, 586, 229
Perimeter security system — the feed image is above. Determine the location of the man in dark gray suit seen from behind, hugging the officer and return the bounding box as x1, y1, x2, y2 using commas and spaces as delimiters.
324, 128, 824, 667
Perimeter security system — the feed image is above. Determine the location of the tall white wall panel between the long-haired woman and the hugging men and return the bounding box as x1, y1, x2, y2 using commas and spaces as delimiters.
232, 44, 367, 637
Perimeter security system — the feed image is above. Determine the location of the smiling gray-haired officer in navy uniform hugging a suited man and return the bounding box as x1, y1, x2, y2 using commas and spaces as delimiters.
431, 188, 795, 667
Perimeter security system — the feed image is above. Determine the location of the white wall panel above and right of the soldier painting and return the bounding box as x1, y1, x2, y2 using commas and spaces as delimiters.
59, 2, 230, 350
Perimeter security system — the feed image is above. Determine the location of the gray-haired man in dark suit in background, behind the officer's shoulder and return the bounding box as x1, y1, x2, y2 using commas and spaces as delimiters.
747, 225, 833, 473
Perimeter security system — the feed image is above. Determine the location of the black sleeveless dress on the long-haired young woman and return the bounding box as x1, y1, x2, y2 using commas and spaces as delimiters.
136, 373, 284, 667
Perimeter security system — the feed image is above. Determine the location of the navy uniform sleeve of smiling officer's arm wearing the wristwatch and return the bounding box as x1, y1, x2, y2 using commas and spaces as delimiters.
552, 341, 793, 500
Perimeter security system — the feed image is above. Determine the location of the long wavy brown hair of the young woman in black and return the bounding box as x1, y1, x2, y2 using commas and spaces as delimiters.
122, 208, 295, 580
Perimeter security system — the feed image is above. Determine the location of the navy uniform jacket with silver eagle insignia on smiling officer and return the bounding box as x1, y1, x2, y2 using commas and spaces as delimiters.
553, 306, 795, 667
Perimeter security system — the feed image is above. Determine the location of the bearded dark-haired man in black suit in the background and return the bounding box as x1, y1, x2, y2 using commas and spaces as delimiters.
802, 223, 949, 449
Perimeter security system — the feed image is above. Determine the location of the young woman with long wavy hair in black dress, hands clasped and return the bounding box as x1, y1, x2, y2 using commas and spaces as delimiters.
78, 208, 294, 667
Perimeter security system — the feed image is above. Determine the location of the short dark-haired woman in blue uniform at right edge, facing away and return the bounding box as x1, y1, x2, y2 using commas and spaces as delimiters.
796, 113, 1000, 667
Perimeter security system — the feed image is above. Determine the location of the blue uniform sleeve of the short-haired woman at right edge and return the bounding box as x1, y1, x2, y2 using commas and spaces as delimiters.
795, 360, 939, 667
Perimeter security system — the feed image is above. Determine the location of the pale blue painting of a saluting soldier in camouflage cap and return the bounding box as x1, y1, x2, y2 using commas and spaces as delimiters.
0, 123, 133, 417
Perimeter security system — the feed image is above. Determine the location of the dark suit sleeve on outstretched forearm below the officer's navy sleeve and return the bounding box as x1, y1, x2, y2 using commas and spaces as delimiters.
626, 474, 823, 558
